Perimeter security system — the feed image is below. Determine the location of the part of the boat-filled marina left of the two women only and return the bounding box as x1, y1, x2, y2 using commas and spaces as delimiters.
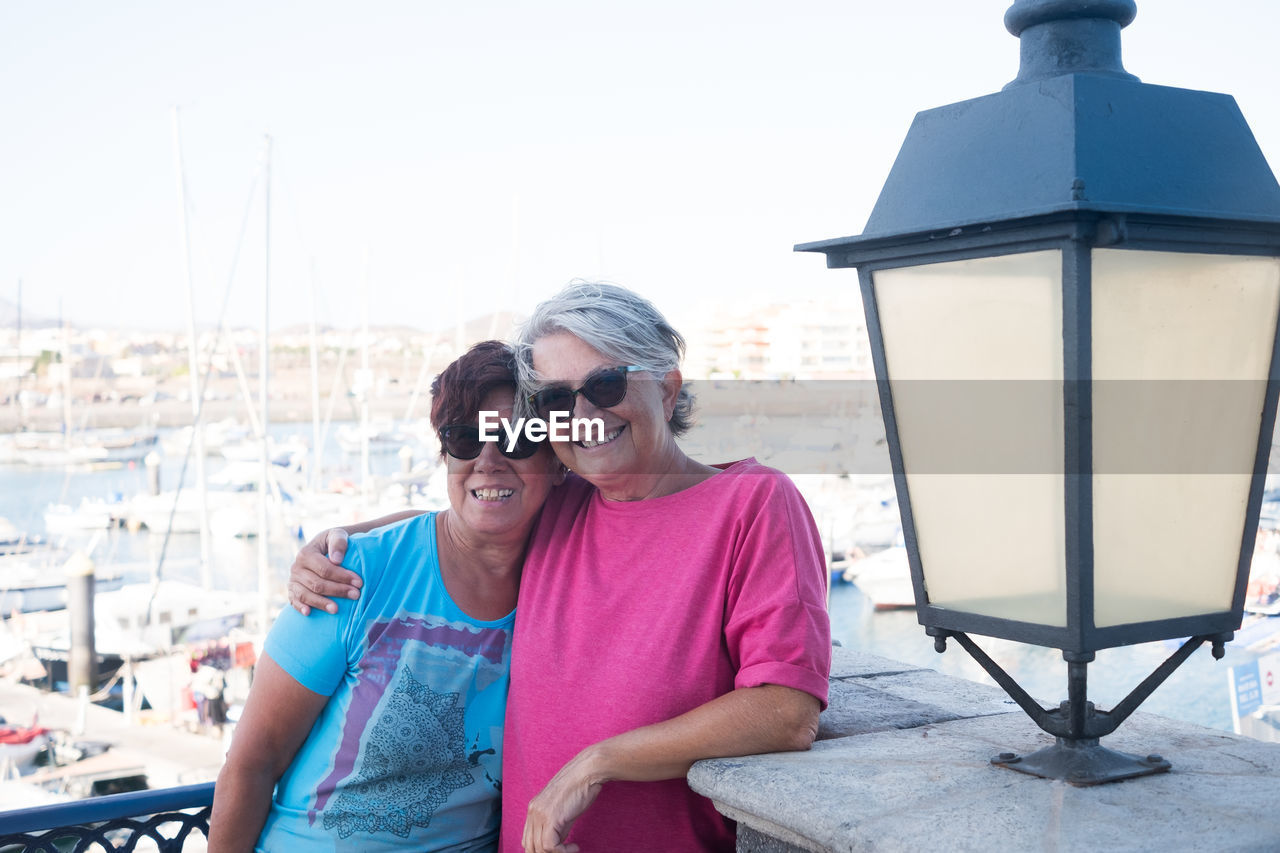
0, 424, 445, 808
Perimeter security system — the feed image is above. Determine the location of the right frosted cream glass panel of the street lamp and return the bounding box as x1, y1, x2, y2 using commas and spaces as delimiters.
1092, 250, 1280, 628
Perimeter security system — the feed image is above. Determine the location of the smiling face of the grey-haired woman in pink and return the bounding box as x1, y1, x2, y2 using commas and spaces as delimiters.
532, 326, 682, 501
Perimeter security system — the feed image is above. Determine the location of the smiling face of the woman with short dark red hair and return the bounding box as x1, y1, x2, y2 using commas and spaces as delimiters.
445, 387, 564, 538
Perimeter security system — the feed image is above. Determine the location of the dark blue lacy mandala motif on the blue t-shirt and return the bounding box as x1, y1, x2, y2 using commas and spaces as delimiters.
324, 667, 475, 838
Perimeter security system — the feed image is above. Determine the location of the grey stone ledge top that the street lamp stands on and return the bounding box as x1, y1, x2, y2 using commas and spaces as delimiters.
689, 648, 1280, 853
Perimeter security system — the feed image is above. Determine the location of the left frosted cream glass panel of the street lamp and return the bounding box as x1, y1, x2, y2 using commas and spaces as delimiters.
872, 250, 1066, 626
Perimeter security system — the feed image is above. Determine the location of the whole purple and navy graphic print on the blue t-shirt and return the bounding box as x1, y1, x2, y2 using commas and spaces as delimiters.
308, 616, 509, 839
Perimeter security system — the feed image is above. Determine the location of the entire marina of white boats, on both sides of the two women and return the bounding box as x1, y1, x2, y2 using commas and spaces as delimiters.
0, 415, 1280, 803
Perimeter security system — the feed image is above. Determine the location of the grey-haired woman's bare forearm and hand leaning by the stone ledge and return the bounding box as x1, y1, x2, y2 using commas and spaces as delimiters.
524, 684, 820, 853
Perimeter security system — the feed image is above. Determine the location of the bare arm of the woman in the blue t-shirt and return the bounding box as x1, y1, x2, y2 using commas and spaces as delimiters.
209, 654, 329, 853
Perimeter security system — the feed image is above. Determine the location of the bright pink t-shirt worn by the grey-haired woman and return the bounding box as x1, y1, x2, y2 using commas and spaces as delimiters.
502, 460, 831, 853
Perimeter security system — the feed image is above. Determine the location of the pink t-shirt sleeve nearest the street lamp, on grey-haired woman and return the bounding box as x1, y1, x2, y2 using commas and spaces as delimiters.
724, 469, 831, 708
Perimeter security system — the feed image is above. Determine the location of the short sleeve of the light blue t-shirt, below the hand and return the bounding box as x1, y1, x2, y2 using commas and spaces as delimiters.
262, 547, 365, 695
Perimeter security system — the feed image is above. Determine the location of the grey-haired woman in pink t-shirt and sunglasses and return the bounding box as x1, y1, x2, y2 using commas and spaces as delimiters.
289, 283, 831, 853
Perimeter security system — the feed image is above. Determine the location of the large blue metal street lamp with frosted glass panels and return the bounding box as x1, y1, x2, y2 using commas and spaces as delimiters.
796, 0, 1280, 785
